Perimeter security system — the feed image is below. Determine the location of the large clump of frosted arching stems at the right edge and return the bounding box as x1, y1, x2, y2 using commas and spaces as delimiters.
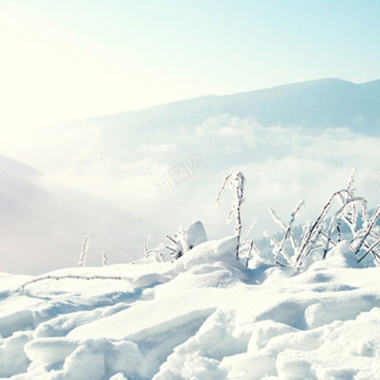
265, 170, 380, 270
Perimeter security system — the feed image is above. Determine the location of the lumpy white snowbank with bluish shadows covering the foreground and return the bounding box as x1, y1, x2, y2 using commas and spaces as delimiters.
0, 237, 380, 380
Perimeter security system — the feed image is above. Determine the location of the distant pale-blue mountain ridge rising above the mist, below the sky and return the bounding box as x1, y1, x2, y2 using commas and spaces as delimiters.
79, 78, 380, 135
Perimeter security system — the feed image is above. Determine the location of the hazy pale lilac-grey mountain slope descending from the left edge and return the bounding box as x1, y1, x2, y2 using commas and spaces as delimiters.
0, 156, 156, 273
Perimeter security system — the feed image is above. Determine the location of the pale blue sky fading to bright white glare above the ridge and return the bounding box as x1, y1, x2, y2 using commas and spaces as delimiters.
0, 0, 380, 130
